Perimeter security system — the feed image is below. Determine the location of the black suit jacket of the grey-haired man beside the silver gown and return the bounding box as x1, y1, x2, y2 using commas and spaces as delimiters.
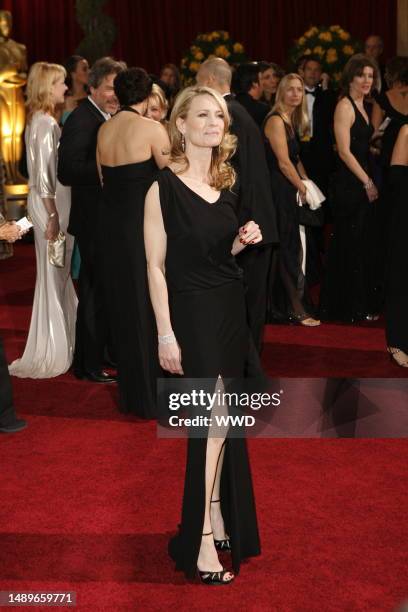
58, 99, 105, 238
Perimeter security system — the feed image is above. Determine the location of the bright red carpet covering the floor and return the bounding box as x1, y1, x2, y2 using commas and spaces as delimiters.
0, 245, 408, 612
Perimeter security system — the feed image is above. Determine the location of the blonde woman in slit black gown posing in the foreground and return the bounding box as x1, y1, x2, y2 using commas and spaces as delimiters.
145, 87, 262, 584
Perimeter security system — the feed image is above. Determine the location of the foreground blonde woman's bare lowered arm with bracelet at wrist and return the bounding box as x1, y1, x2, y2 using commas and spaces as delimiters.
144, 182, 183, 374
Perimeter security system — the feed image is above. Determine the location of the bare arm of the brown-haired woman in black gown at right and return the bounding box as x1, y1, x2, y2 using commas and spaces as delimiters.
334, 98, 378, 202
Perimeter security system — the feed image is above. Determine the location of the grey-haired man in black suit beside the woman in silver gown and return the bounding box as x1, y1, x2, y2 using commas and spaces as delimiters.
58, 57, 126, 383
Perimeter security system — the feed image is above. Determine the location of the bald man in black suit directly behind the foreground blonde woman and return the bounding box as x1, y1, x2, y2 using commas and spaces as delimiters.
197, 58, 278, 351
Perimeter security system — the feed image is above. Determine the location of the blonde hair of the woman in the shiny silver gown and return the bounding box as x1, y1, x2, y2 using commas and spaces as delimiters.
26, 62, 67, 122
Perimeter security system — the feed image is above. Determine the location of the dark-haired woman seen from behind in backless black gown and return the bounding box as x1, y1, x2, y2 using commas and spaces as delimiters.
97, 68, 170, 418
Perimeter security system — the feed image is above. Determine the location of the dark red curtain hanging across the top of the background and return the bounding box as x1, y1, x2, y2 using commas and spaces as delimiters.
0, 0, 397, 72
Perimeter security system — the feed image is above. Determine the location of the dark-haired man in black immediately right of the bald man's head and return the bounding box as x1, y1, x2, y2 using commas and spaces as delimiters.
234, 62, 270, 129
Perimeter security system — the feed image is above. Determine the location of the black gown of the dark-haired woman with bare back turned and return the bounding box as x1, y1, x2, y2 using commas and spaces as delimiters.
100, 158, 161, 418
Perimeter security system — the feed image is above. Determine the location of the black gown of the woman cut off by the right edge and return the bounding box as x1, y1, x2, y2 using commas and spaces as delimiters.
385, 165, 408, 353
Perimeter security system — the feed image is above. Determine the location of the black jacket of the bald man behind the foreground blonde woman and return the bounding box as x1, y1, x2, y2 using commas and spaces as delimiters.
225, 95, 279, 244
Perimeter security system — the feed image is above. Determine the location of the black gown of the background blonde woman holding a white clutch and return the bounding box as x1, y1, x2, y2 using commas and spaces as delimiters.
265, 112, 313, 320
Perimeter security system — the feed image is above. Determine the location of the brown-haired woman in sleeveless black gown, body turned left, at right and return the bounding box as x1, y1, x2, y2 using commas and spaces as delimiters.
321, 55, 378, 322
